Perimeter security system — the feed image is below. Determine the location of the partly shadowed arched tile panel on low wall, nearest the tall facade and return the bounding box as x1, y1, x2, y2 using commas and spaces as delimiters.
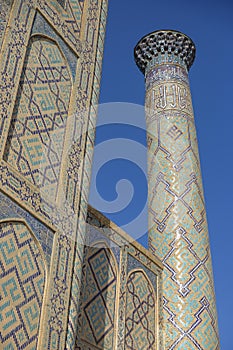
81, 247, 117, 350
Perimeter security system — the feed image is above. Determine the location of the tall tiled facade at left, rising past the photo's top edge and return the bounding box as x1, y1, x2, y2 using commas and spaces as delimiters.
0, 0, 107, 350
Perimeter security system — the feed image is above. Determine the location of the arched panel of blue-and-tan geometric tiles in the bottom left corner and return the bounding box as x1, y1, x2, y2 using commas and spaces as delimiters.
0, 222, 45, 350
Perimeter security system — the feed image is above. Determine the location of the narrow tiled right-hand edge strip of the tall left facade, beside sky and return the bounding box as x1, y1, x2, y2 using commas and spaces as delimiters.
67, 0, 108, 348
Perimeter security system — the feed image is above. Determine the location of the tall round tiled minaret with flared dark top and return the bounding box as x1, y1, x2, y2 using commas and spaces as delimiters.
135, 30, 219, 350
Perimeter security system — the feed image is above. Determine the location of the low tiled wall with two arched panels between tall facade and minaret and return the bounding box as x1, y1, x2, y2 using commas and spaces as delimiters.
75, 207, 163, 350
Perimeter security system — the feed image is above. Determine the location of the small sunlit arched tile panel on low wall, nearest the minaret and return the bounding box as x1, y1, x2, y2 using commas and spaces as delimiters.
125, 271, 157, 350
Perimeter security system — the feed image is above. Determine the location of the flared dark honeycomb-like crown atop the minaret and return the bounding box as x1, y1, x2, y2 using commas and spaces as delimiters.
134, 30, 196, 74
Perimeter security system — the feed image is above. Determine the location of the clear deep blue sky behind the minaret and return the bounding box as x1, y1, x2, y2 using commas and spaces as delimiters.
88, 0, 233, 350
